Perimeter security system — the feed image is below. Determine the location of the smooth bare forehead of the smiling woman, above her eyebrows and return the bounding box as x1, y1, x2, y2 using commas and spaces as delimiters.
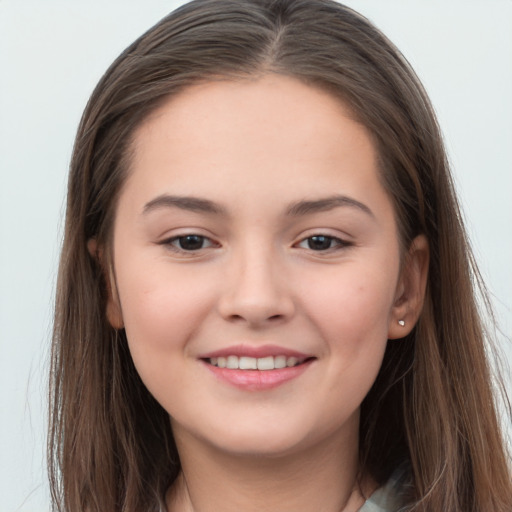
123, 75, 388, 216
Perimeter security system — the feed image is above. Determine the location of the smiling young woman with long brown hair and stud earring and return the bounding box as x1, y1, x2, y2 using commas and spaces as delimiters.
50, 0, 512, 512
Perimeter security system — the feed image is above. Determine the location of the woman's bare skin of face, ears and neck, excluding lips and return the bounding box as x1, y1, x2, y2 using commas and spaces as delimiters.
103, 75, 428, 512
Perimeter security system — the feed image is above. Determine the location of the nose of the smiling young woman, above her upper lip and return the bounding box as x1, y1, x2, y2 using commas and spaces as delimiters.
218, 247, 295, 328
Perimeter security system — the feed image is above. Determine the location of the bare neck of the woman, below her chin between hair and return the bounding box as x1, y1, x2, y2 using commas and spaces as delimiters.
167, 416, 374, 512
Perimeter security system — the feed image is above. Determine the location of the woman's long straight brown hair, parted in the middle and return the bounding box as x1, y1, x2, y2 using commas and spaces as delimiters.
49, 0, 512, 512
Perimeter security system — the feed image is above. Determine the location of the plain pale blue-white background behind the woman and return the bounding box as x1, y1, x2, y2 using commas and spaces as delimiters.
0, 0, 512, 512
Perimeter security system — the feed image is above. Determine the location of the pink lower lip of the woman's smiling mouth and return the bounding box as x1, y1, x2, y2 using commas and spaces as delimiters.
203, 359, 314, 391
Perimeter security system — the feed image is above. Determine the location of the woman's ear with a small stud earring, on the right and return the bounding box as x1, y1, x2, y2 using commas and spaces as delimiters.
388, 235, 429, 339
